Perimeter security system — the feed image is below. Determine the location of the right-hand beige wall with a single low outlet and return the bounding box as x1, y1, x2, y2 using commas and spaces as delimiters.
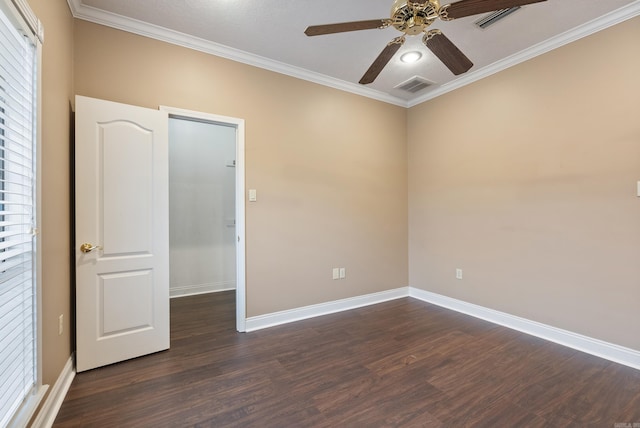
408, 18, 640, 349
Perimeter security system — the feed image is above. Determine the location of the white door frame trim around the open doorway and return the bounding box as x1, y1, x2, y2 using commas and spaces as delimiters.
160, 106, 247, 332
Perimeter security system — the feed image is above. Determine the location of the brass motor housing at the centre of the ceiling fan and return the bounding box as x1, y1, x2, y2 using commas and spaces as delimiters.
391, 0, 440, 36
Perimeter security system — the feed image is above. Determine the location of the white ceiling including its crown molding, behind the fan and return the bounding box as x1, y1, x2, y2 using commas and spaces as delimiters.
68, 0, 640, 106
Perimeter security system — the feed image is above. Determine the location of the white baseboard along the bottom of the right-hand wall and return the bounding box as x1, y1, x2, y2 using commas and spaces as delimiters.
409, 287, 640, 370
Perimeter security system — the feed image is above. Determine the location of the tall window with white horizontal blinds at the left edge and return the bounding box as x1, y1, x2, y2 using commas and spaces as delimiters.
0, 0, 44, 427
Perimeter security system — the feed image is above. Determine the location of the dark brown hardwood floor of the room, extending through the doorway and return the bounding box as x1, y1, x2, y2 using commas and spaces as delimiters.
54, 292, 640, 428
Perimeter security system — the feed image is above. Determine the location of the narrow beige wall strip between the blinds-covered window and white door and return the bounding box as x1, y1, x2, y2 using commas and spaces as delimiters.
29, 0, 73, 385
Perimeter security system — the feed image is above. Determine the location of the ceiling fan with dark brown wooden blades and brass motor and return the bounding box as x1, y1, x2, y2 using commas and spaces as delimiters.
304, 0, 546, 85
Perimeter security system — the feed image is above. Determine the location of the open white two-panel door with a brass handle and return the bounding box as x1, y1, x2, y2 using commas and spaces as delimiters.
75, 96, 169, 372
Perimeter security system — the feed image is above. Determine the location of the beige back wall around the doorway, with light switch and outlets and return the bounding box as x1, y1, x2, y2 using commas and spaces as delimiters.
75, 21, 408, 316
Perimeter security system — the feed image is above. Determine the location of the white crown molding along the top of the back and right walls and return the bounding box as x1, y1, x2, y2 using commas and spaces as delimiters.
67, 0, 640, 108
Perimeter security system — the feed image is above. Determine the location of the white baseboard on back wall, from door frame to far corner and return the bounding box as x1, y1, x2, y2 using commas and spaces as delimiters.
246, 287, 409, 332
